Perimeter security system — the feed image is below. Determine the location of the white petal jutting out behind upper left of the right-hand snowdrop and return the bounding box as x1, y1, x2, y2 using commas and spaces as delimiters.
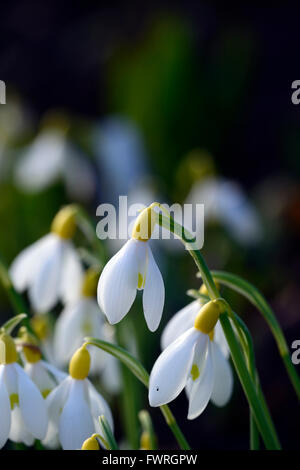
161, 300, 201, 349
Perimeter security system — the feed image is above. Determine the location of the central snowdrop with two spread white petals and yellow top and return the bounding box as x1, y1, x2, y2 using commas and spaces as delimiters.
98, 206, 165, 331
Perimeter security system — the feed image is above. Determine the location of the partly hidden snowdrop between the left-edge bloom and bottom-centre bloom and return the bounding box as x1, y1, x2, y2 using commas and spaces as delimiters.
19, 327, 67, 398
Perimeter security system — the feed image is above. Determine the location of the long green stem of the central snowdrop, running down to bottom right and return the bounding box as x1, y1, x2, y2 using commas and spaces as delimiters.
157, 213, 280, 449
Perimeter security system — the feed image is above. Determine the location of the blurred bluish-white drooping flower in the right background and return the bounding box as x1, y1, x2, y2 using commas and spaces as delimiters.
186, 177, 262, 245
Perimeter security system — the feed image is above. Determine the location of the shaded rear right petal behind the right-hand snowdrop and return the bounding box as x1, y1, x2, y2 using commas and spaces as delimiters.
211, 342, 233, 406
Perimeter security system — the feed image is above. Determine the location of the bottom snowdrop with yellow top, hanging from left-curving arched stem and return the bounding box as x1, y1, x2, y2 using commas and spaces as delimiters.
43, 345, 113, 450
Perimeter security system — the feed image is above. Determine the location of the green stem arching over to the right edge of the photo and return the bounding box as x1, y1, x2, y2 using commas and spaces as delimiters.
212, 271, 300, 400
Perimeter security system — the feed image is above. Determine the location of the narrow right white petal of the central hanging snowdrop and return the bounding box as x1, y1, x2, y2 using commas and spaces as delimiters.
142, 246, 165, 331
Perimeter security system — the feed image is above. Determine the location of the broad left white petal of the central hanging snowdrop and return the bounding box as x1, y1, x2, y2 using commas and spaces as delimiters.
98, 240, 138, 324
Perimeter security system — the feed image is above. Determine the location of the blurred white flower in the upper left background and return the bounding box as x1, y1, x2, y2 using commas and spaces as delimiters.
15, 129, 96, 201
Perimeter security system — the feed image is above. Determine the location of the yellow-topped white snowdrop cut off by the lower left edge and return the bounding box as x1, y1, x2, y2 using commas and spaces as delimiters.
0, 333, 48, 447
